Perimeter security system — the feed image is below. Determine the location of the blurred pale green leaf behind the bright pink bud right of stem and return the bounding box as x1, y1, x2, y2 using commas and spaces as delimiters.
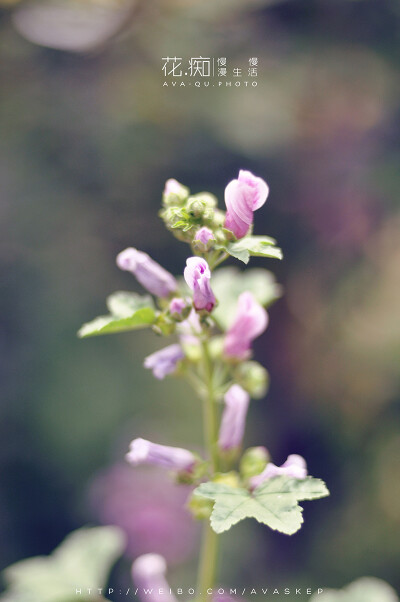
211, 267, 282, 330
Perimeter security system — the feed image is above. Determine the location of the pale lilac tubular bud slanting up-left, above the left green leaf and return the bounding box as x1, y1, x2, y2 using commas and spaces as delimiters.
117, 247, 178, 297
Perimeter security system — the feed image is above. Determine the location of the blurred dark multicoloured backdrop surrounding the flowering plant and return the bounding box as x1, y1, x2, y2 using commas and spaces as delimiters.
0, 0, 400, 590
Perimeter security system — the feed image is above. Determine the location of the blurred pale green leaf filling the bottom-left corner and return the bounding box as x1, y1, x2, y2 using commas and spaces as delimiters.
0, 527, 125, 602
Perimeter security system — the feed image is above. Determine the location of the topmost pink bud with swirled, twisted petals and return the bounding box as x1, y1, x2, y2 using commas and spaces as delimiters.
225, 170, 269, 238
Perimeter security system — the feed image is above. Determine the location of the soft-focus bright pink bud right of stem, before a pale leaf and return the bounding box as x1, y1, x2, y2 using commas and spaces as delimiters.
224, 292, 268, 359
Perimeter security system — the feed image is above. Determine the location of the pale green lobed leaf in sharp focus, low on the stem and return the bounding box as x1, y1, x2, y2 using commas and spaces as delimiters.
195, 476, 329, 535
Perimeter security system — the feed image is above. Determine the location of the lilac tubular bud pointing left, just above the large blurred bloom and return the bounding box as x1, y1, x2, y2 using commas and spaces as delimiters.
126, 439, 196, 472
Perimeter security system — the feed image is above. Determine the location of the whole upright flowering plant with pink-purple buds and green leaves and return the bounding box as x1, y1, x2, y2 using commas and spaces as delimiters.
79, 171, 329, 598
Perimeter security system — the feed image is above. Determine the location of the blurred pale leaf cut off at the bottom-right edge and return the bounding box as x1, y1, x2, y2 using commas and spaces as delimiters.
310, 577, 399, 602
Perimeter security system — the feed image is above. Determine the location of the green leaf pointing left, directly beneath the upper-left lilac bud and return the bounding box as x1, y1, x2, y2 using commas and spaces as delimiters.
78, 291, 157, 338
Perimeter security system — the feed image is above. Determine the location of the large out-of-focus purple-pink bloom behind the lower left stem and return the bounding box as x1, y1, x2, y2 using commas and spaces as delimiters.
89, 462, 198, 565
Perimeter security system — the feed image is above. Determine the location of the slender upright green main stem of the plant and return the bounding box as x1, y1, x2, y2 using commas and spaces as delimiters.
197, 341, 218, 600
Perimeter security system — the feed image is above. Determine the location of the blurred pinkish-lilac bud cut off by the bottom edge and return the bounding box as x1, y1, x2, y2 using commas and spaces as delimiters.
132, 554, 176, 602
